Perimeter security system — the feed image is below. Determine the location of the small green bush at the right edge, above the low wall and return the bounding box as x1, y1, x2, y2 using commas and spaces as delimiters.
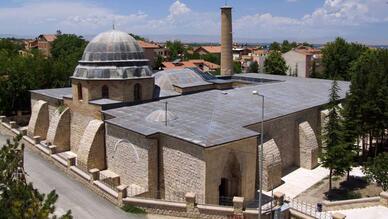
363, 153, 388, 191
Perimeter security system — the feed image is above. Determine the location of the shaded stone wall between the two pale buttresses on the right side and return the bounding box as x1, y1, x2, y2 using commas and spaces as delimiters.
248, 107, 320, 171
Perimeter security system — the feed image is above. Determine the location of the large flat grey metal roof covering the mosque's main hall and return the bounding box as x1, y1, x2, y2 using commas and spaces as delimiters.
104, 74, 349, 147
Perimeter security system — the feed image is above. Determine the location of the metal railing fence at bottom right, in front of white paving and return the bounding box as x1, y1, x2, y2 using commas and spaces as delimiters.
285, 197, 333, 219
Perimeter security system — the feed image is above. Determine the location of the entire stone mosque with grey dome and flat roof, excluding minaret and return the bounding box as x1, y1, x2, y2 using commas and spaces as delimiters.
27, 7, 349, 204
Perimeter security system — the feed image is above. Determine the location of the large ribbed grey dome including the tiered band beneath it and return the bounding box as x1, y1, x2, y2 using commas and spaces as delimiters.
73, 30, 152, 80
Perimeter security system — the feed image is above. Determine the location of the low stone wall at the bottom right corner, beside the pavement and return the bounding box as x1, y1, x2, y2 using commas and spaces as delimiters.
322, 192, 388, 211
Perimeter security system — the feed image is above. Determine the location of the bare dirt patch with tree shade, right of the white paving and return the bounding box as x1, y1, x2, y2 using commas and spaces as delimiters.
296, 176, 382, 203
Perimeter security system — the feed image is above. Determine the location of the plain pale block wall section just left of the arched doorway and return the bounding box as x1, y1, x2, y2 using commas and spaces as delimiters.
159, 135, 207, 203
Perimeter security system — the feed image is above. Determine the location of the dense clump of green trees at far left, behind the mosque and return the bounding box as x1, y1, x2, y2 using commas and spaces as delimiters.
0, 34, 86, 115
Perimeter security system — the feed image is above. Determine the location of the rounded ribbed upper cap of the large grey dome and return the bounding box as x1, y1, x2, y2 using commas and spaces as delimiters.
81, 30, 144, 62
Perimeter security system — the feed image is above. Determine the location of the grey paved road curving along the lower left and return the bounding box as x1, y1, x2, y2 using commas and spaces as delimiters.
0, 134, 149, 219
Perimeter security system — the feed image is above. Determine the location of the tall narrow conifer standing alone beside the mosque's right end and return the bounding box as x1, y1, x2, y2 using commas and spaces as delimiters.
320, 80, 349, 191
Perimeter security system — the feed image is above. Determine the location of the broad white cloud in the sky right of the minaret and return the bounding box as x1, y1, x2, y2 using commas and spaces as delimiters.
235, 0, 387, 42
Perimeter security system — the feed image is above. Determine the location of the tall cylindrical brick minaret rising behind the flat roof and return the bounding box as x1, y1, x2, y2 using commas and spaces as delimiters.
221, 6, 233, 76
